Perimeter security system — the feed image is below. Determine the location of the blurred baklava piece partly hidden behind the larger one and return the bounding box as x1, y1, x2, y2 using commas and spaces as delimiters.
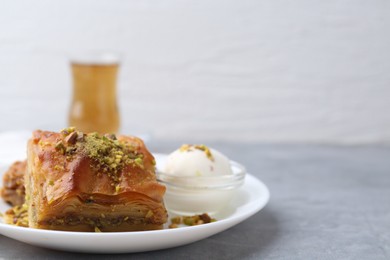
1, 161, 26, 206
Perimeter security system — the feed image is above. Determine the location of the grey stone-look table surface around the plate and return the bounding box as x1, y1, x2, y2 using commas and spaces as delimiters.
0, 142, 390, 259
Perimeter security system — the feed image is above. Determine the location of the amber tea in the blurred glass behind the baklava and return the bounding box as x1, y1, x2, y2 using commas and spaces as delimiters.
69, 63, 119, 134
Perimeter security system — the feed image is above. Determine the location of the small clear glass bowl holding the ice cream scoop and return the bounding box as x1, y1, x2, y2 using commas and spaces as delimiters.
157, 161, 246, 215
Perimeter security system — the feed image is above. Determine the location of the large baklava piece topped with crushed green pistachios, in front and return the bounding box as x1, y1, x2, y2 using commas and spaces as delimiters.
25, 128, 167, 232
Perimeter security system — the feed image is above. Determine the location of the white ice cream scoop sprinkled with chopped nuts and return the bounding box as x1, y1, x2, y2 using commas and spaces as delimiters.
164, 145, 233, 176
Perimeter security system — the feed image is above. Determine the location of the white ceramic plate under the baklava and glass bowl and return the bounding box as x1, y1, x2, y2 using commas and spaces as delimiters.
0, 153, 269, 253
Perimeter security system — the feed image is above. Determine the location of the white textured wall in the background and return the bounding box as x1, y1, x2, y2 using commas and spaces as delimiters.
0, 0, 390, 143
